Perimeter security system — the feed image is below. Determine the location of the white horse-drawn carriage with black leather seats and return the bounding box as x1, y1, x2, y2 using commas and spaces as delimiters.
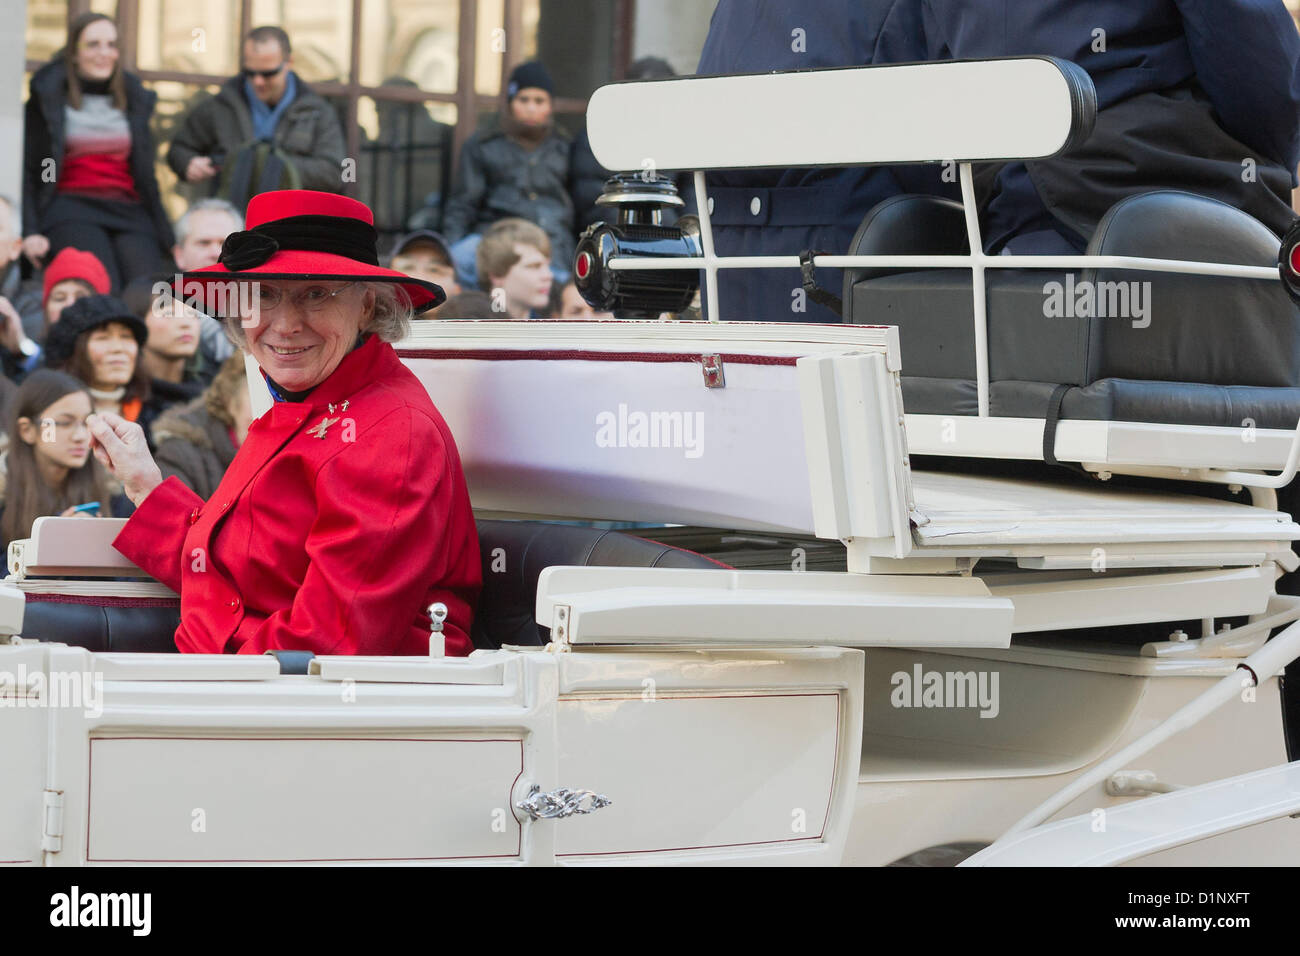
0, 59, 1300, 865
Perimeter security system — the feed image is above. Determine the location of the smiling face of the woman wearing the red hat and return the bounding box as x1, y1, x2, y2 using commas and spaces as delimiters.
244, 281, 374, 392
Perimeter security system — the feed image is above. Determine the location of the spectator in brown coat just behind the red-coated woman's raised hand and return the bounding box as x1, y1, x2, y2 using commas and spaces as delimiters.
153, 354, 252, 499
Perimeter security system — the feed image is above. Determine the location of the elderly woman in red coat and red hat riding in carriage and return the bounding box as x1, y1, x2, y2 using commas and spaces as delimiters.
90, 190, 481, 654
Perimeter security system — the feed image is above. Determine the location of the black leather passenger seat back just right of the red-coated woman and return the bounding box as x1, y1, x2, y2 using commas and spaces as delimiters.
471, 519, 727, 649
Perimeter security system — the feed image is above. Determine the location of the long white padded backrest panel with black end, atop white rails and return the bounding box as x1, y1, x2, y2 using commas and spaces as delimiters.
588, 56, 1096, 170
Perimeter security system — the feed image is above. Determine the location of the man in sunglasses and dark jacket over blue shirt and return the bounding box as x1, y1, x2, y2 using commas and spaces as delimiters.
166, 26, 345, 211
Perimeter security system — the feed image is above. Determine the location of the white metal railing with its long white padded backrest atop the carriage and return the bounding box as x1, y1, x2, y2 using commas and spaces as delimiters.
588, 57, 1300, 489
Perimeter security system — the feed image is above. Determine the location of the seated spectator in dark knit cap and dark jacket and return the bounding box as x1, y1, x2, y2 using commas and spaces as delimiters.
442, 61, 576, 284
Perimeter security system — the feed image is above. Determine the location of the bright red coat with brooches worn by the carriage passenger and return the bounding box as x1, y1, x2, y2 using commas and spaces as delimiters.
113, 336, 482, 656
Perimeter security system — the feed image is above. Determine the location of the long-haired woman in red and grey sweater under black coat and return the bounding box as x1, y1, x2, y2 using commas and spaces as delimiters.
22, 13, 173, 290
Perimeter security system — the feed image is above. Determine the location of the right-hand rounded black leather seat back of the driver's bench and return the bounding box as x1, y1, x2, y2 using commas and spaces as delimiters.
1083, 190, 1300, 388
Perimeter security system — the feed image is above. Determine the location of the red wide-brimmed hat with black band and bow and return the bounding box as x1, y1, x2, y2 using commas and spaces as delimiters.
177, 189, 447, 313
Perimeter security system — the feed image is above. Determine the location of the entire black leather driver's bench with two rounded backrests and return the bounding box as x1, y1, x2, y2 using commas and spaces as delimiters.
844, 190, 1300, 428
